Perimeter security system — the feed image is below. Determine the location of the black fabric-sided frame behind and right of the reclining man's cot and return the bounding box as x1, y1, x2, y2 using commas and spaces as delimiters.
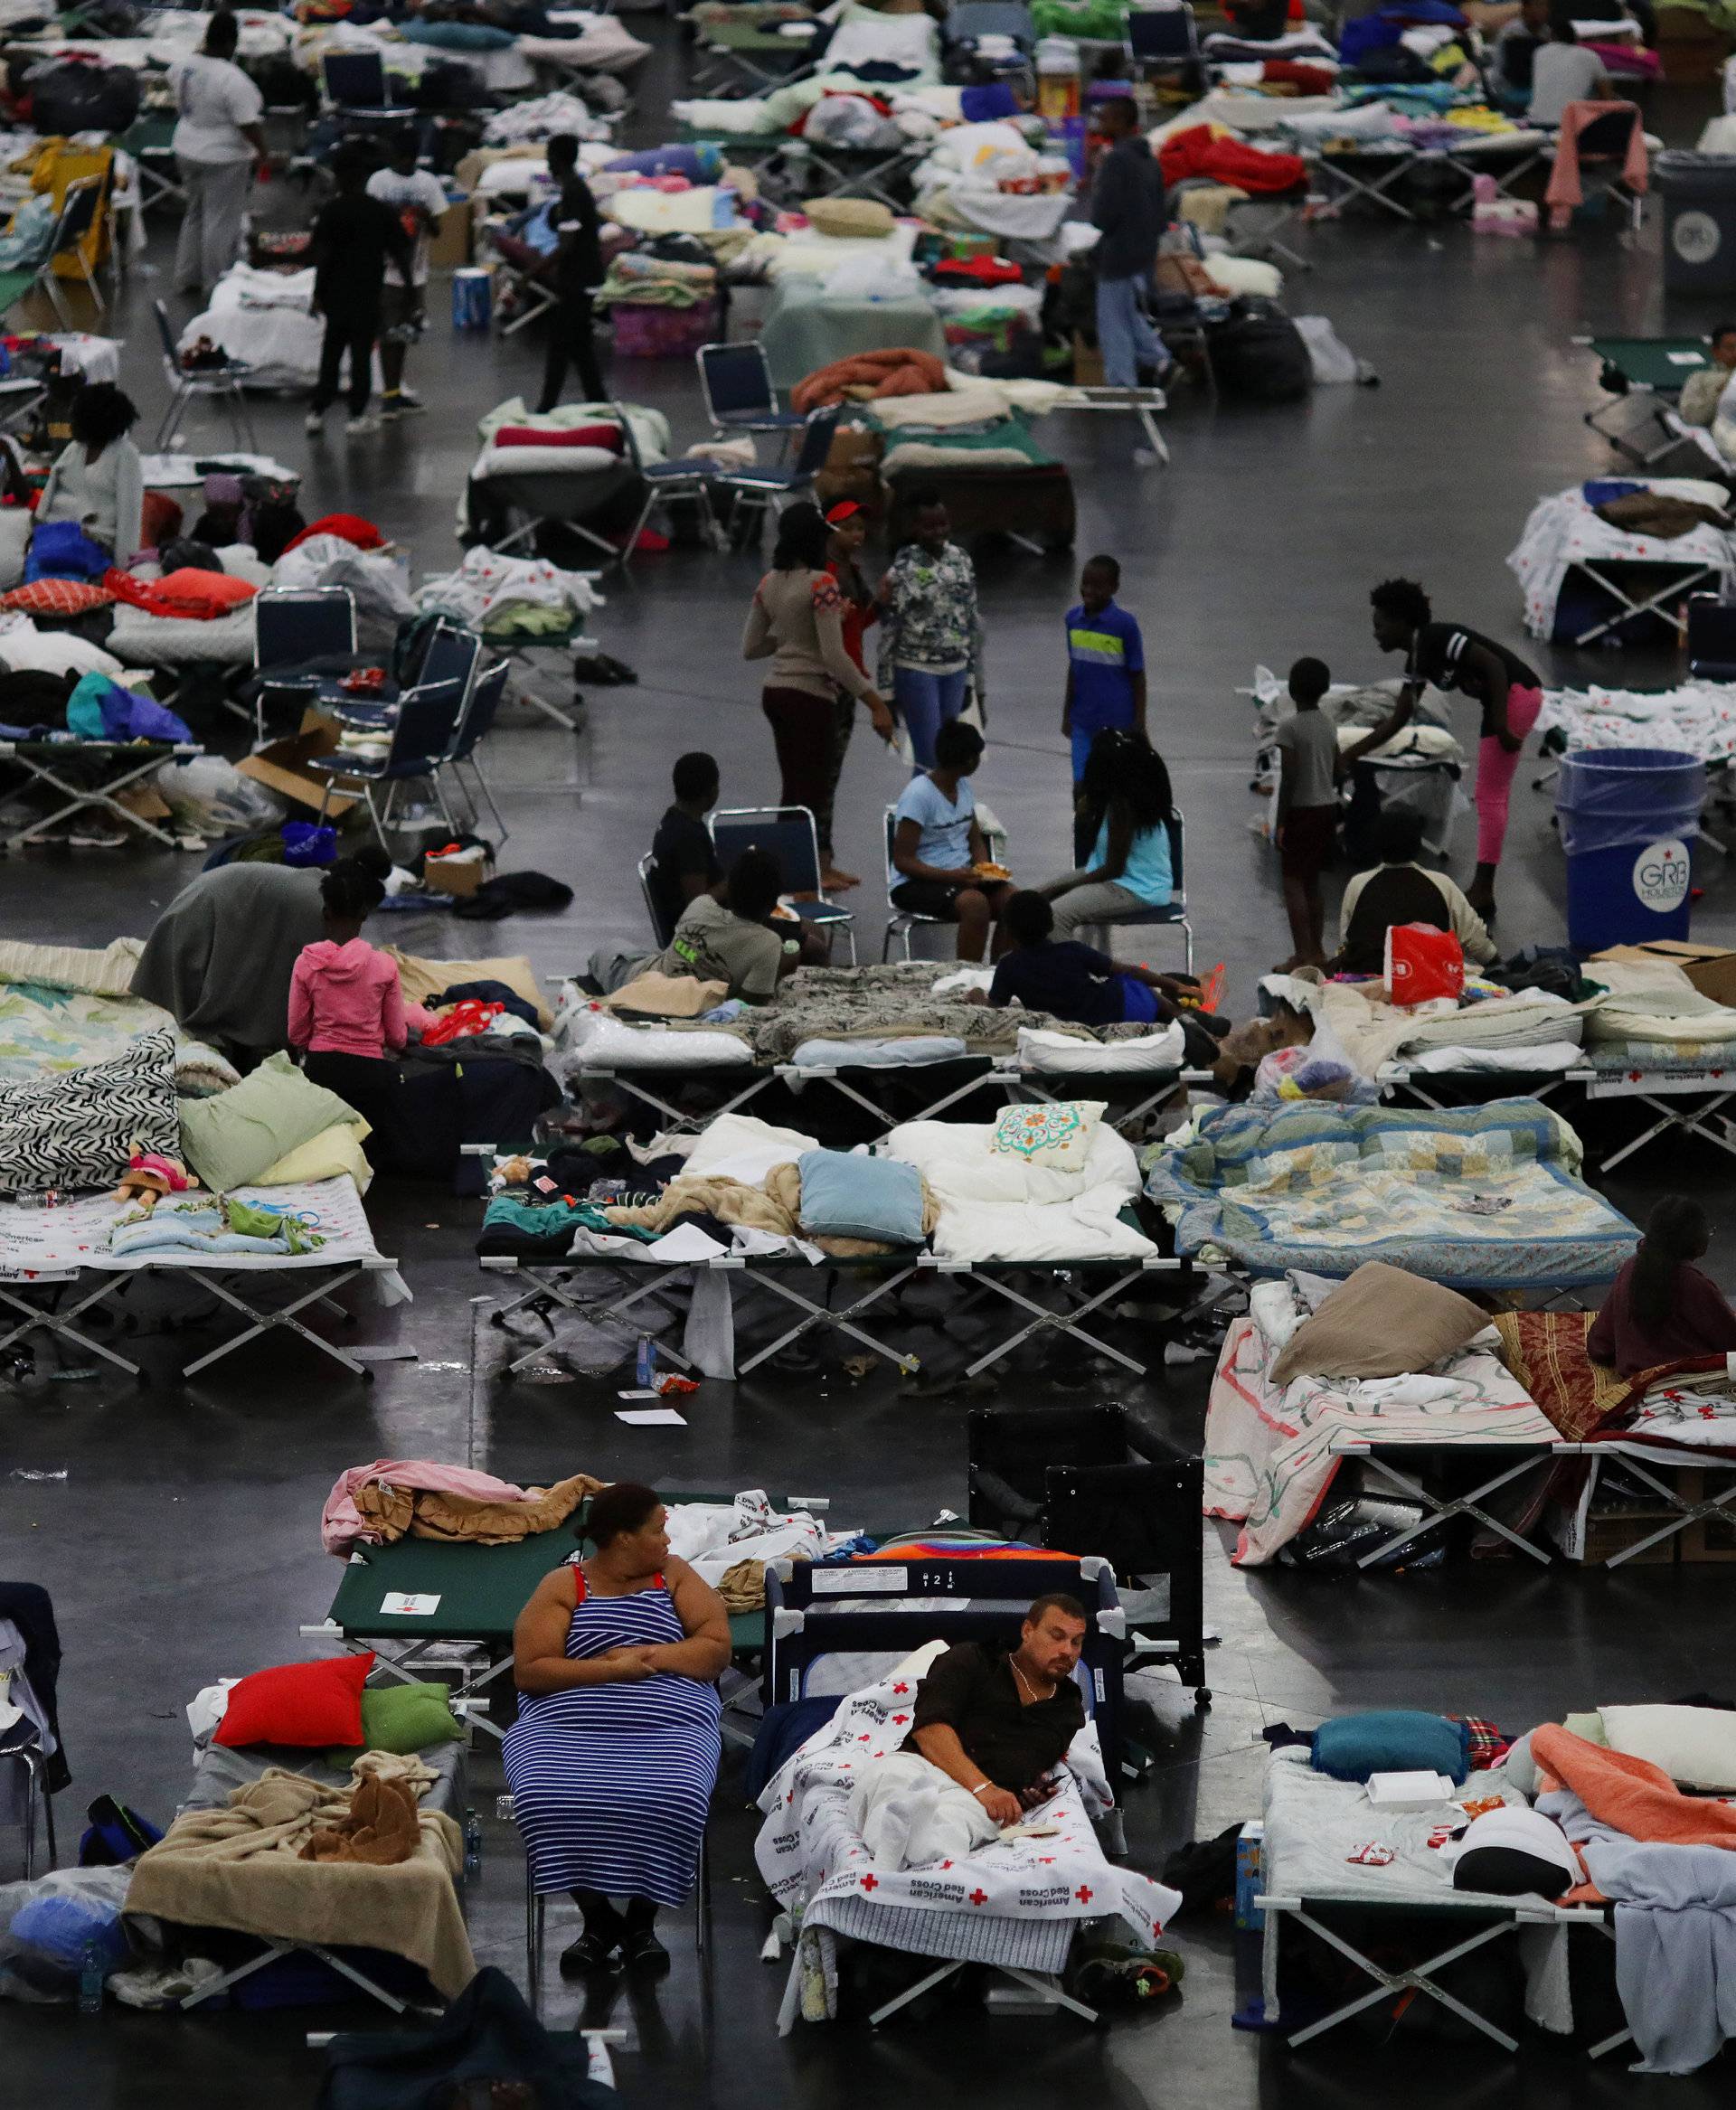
966, 1405, 1211, 1707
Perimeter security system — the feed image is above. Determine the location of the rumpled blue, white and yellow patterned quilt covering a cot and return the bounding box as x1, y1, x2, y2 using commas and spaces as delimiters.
1146, 1099, 1639, 1289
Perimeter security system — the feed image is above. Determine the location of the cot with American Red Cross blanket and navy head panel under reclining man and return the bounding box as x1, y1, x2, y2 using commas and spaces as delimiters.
758, 1553, 1175, 2032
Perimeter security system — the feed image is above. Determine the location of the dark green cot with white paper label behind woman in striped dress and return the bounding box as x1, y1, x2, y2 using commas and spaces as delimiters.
299, 1493, 831, 1738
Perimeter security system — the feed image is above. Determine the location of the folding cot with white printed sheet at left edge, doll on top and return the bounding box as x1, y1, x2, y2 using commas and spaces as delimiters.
0, 1173, 396, 1384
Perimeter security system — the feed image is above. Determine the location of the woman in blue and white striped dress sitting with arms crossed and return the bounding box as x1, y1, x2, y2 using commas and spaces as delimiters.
502, 1481, 730, 1975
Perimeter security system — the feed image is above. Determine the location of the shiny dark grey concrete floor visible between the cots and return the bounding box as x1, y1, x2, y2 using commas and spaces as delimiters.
0, 37, 1736, 2110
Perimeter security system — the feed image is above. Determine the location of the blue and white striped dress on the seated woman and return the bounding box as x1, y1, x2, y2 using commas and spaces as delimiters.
502, 1568, 723, 1906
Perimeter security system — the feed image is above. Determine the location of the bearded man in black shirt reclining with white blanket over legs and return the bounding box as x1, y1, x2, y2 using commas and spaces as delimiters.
850, 1591, 1086, 1868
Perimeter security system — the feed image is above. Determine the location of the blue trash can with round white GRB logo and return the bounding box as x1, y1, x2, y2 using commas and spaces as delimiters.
1554, 747, 1706, 952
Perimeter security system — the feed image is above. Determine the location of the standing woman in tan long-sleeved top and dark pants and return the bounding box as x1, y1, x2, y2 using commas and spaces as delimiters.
741, 504, 892, 884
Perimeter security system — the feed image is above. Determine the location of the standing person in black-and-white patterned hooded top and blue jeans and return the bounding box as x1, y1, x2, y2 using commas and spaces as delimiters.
880, 489, 983, 770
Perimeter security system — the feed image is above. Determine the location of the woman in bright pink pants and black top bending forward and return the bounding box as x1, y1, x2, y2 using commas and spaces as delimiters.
1344, 579, 1544, 922
